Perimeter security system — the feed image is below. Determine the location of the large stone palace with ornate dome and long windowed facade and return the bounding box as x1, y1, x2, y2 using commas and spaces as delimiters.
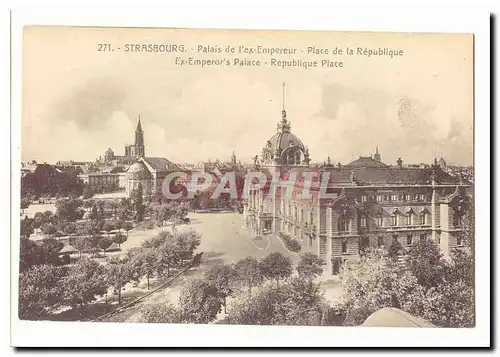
244, 104, 472, 274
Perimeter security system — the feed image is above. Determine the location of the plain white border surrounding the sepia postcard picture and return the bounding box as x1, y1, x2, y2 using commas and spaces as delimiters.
11, 1, 490, 347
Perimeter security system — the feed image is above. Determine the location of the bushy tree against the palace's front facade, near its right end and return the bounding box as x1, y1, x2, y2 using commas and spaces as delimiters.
406, 239, 445, 288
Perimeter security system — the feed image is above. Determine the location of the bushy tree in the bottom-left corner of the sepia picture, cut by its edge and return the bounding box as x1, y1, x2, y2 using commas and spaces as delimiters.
19, 265, 67, 320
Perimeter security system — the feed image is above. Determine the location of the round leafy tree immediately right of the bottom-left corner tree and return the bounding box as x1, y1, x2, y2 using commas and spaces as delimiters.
62, 258, 108, 308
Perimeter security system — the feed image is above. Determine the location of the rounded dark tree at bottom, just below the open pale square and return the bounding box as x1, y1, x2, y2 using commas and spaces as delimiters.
179, 279, 222, 324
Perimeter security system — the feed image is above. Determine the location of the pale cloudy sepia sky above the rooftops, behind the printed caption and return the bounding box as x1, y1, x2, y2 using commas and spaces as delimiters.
21, 27, 473, 165
